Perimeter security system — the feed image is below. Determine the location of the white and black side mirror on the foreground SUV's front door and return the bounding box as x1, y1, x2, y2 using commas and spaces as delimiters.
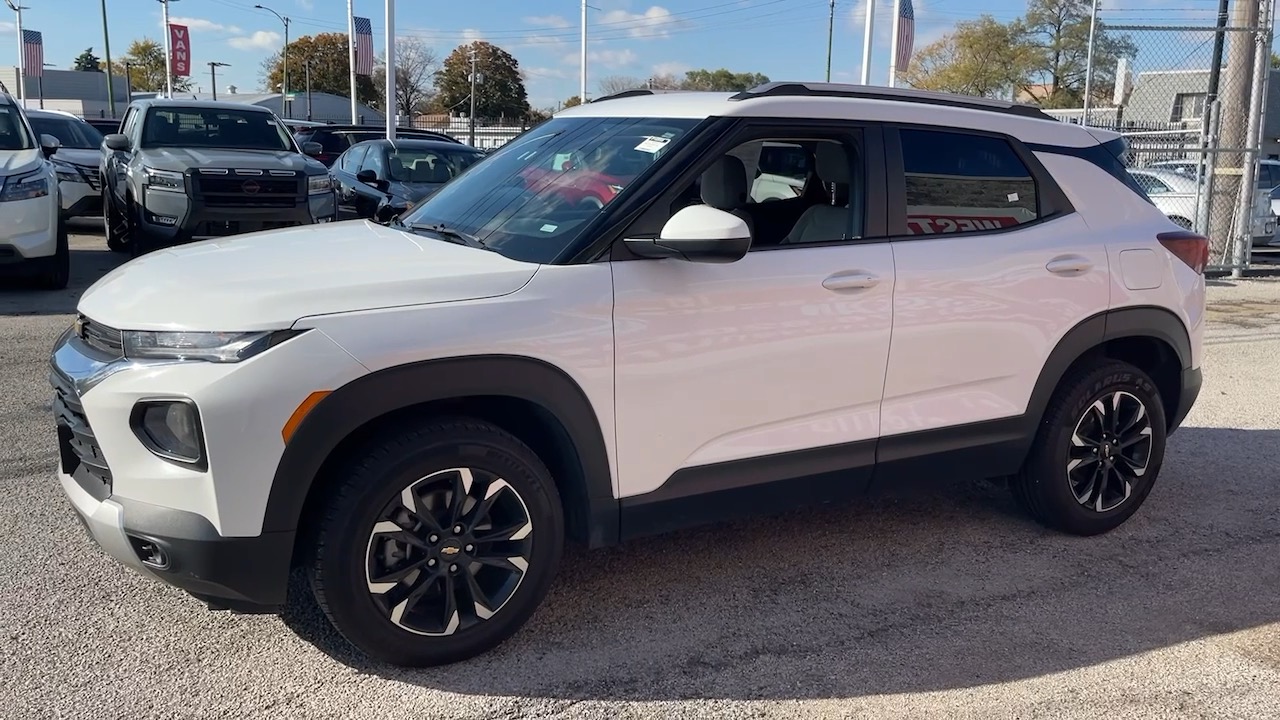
623, 205, 751, 263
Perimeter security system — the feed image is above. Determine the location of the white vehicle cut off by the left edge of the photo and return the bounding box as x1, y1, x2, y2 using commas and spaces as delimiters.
0, 88, 70, 290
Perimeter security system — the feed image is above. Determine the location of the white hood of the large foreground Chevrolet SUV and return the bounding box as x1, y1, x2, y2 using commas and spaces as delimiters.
78, 220, 538, 332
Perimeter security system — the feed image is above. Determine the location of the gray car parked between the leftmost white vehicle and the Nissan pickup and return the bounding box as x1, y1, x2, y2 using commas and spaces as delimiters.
27, 109, 102, 218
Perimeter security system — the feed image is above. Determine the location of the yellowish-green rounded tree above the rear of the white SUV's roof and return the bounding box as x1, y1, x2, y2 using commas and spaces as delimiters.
905, 15, 1037, 97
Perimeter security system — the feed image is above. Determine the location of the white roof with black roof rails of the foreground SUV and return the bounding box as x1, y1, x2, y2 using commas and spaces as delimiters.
556, 82, 1105, 147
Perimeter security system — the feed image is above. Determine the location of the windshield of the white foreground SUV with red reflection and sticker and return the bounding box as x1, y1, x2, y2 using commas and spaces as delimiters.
403, 117, 700, 263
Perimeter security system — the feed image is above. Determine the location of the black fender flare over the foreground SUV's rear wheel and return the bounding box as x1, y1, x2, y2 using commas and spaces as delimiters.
1024, 305, 1192, 425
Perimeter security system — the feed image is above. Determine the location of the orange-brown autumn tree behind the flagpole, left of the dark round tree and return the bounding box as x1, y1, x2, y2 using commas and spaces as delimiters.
261, 32, 381, 108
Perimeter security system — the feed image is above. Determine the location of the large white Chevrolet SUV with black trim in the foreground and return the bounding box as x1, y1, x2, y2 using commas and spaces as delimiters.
51, 83, 1208, 665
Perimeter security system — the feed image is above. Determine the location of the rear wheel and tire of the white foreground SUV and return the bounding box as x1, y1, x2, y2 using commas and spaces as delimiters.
1010, 360, 1167, 536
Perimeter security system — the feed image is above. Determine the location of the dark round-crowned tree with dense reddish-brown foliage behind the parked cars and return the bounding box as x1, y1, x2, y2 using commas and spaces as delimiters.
435, 40, 532, 118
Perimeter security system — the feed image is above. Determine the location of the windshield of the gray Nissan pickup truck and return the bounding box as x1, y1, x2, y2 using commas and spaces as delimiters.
142, 108, 296, 151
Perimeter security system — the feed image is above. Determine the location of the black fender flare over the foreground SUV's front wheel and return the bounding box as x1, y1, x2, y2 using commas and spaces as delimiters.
262, 355, 618, 546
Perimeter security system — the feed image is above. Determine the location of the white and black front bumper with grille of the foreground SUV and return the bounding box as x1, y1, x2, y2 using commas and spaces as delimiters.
49, 322, 364, 604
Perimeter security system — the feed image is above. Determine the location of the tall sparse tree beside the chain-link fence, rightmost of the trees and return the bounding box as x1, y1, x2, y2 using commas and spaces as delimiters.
1021, 0, 1138, 108
